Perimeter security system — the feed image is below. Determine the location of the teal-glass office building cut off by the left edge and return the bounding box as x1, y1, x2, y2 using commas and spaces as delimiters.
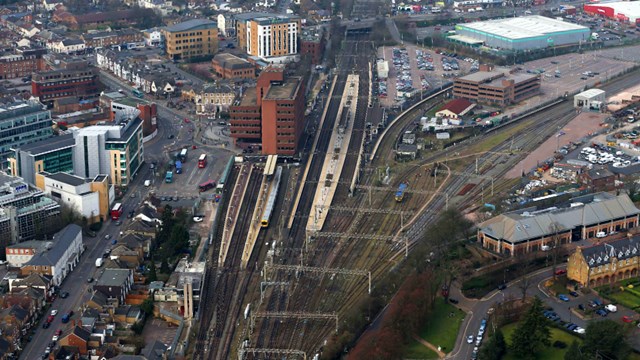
0, 99, 53, 169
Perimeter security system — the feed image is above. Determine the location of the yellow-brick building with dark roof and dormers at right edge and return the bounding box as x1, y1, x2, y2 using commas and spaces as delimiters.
567, 237, 640, 287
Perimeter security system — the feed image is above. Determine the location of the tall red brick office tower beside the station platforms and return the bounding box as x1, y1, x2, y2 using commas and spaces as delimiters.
229, 66, 305, 156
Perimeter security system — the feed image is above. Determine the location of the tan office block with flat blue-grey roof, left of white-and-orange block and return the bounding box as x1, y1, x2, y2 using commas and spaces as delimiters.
162, 19, 218, 61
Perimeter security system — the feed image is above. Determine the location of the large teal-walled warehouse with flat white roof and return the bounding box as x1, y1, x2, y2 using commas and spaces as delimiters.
448, 15, 591, 51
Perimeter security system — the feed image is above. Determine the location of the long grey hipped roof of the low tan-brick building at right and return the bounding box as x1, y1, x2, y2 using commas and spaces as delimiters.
479, 193, 640, 243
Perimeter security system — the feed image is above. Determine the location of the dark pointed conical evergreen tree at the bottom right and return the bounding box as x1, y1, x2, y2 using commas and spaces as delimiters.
511, 297, 551, 359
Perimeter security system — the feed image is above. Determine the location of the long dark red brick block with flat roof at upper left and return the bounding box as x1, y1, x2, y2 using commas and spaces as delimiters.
31, 67, 101, 106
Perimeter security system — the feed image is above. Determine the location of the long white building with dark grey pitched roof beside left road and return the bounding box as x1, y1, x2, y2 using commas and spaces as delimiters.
17, 224, 84, 286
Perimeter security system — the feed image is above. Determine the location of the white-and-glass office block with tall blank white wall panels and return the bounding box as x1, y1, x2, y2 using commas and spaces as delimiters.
73, 118, 144, 186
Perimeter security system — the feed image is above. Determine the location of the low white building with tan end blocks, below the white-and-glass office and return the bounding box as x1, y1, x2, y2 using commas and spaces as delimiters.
36, 172, 115, 224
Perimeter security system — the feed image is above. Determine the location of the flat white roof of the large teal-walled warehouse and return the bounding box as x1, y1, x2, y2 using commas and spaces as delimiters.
459, 15, 589, 39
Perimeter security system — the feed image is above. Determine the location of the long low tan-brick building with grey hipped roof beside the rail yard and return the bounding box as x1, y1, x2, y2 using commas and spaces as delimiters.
478, 192, 640, 256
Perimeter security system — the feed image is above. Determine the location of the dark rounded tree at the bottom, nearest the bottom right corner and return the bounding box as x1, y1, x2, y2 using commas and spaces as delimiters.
582, 319, 629, 359
